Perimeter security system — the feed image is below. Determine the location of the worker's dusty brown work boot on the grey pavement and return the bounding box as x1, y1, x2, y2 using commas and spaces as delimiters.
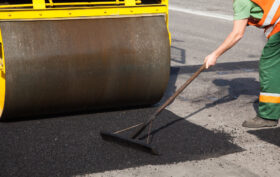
242, 116, 278, 128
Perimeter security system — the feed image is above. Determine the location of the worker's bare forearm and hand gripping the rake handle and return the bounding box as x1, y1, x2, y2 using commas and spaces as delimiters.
204, 19, 248, 68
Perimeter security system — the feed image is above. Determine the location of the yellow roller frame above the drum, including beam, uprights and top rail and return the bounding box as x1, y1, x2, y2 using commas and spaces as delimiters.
0, 0, 168, 21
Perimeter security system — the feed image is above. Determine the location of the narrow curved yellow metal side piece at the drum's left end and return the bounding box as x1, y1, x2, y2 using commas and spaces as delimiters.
0, 29, 6, 117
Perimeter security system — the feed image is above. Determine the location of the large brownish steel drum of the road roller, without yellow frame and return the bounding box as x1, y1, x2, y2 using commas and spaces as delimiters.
0, 16, 170, 118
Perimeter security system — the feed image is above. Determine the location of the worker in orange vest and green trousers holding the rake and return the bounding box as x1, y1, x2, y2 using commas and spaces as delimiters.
204, 0, 280, 128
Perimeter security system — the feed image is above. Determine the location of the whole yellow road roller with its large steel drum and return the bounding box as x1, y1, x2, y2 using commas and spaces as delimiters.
0, 0, 170, 120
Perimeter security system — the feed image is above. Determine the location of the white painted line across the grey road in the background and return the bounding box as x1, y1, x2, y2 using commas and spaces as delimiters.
168, 5, 233, 21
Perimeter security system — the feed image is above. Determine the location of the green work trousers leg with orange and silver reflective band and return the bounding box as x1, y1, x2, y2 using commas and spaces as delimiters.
258, 32, 280, 120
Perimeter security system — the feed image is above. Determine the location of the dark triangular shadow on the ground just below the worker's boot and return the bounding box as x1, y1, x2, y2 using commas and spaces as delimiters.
248, 127, 280, 147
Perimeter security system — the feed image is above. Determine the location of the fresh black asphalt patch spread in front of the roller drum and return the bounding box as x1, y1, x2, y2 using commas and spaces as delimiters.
0, 108, 243, 177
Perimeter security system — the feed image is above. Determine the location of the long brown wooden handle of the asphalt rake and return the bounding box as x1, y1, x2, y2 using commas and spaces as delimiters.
132, 64, 206, 139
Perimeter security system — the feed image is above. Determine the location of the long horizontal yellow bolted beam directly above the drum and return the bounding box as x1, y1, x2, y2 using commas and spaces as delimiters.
0, 5, 168, 21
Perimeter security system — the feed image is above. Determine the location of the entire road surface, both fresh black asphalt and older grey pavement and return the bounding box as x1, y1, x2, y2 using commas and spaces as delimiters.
0, 0, 280, 177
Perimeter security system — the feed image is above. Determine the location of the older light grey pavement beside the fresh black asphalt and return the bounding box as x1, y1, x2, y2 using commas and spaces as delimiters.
95, 0, 280, 177
